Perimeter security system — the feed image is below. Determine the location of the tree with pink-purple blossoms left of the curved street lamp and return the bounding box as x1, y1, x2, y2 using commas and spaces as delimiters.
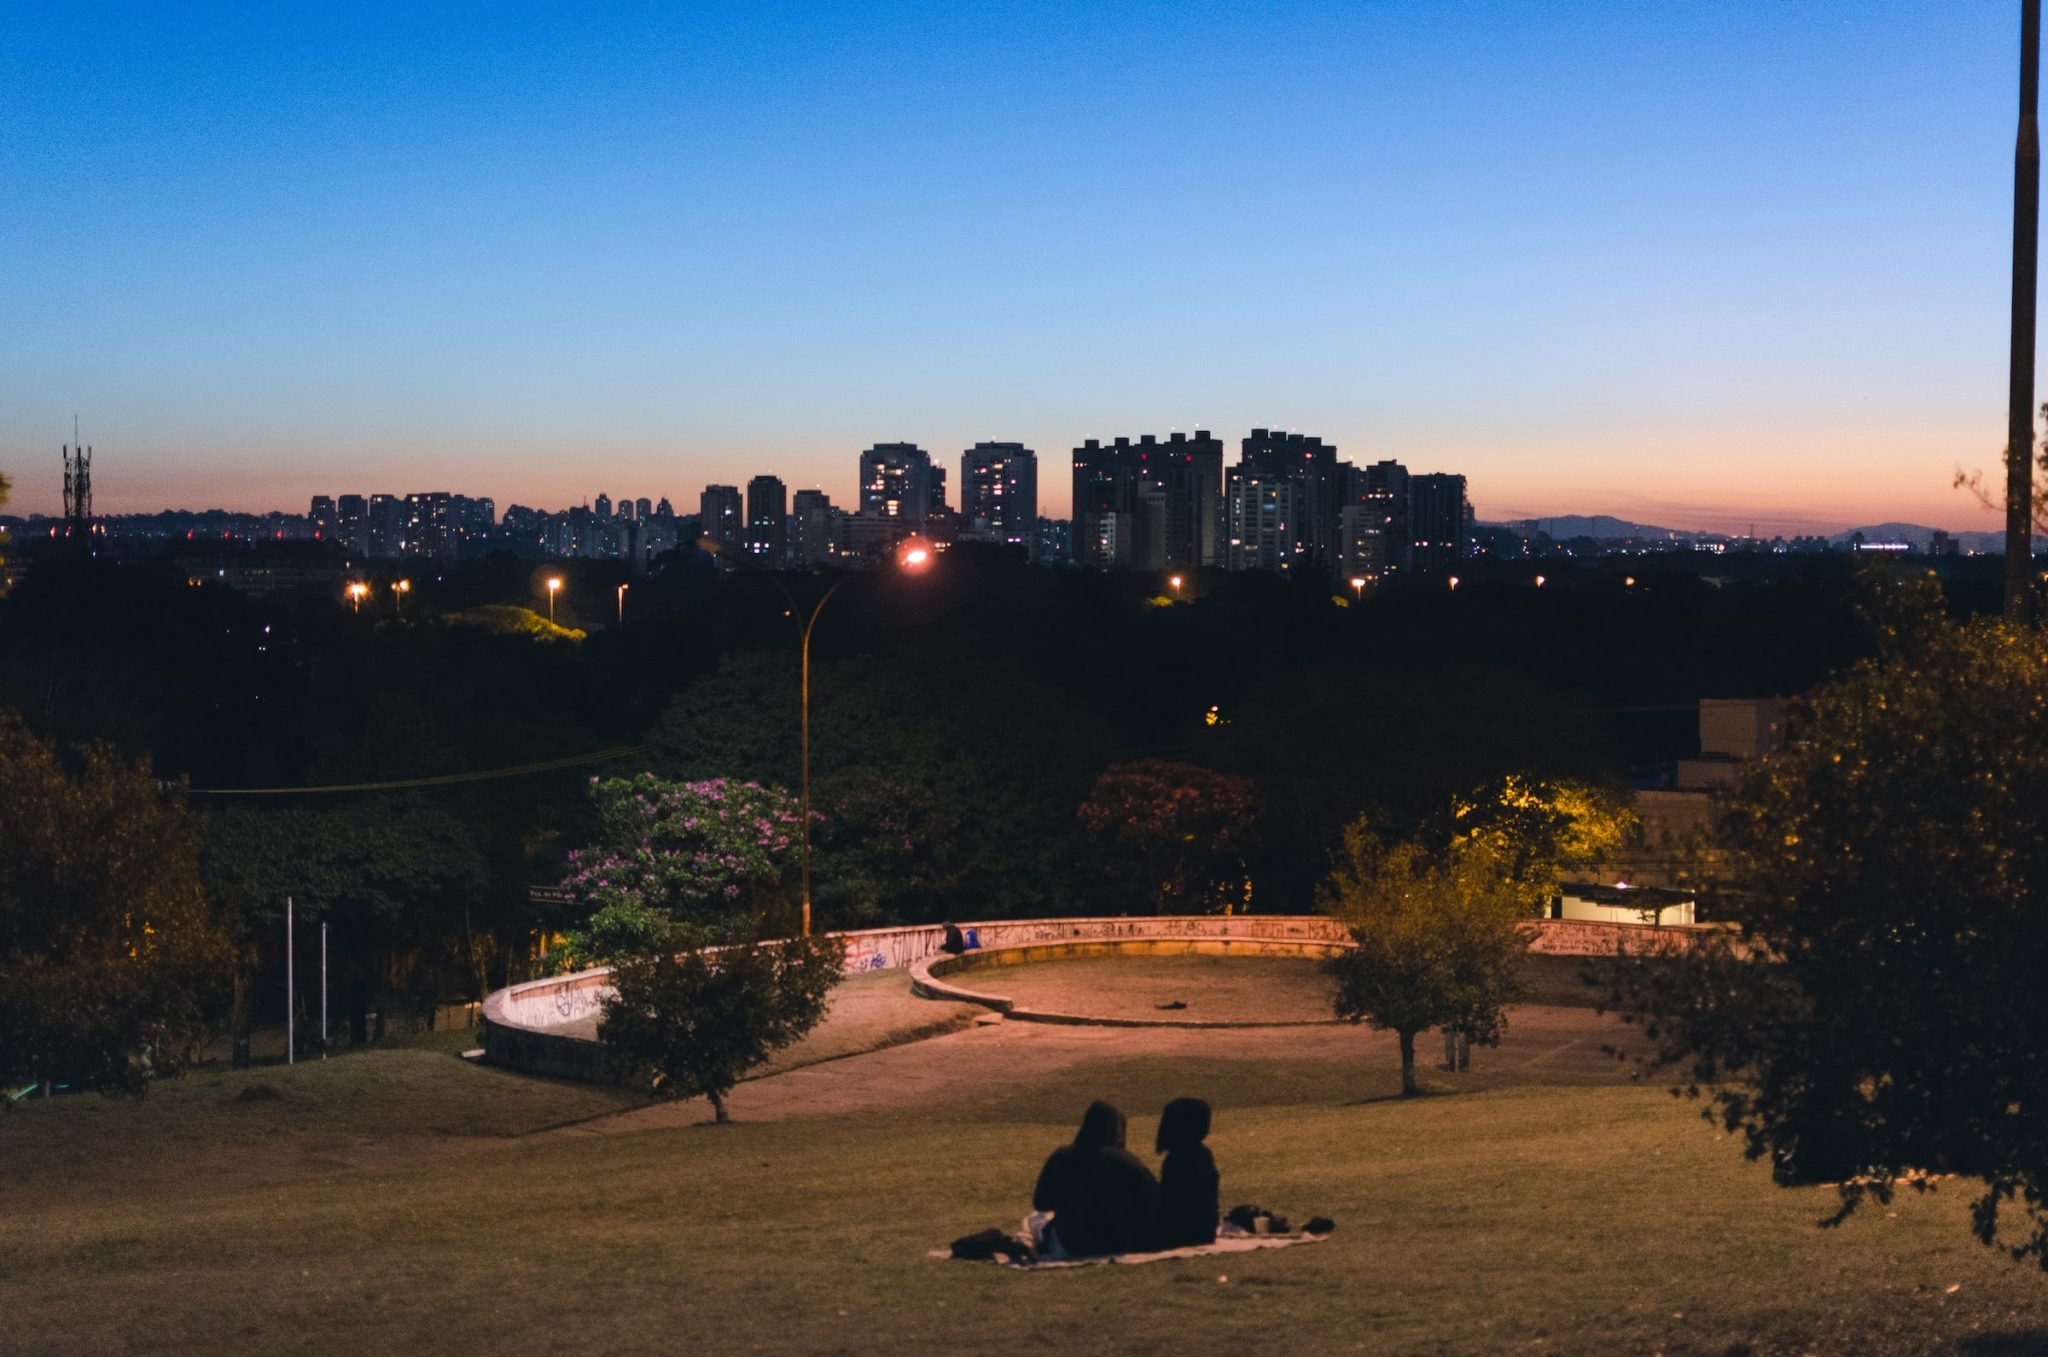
563, 774, 803, 964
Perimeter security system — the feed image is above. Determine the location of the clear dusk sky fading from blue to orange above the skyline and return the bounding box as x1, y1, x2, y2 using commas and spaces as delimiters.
0, 0, 2048, 532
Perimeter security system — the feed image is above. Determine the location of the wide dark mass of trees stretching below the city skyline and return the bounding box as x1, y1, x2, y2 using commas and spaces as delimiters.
0, 546, 1868, 1040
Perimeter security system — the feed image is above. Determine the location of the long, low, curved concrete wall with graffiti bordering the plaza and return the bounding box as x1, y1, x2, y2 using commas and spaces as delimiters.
483, 915, 1700, 1083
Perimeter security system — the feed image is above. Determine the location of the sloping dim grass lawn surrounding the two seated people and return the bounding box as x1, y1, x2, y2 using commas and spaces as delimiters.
0, 1002, 2048, 1357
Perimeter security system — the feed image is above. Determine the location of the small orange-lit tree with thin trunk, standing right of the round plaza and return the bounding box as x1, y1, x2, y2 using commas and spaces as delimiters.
1321, 821, 1526, 1097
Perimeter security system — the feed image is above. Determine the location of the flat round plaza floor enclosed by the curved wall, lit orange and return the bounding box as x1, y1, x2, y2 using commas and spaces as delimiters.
948, 954, 1335, 1023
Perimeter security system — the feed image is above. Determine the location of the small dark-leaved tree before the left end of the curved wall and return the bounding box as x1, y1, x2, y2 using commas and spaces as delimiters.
598, 935, 844, 1122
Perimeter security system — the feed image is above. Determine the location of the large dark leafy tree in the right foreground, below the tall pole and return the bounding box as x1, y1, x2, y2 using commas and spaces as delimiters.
1616, 601, 2048, 1267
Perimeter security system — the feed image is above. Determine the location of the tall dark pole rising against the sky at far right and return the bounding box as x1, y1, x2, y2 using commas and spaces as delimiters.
2005, 0, 2042, 622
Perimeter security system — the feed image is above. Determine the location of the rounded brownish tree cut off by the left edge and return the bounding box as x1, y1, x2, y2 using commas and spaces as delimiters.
0, 714, 229, 1089
